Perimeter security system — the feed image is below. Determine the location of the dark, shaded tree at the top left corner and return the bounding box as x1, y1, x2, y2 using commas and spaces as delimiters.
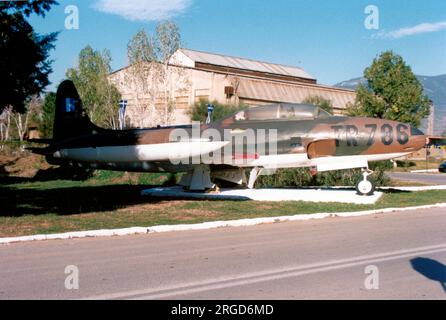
0, 0, 57, 112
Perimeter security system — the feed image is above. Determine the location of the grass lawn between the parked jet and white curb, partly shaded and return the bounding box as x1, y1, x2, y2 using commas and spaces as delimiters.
0, 174, 446, 237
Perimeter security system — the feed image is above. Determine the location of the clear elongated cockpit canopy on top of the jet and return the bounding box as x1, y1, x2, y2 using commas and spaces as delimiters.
234, 103, 331, 122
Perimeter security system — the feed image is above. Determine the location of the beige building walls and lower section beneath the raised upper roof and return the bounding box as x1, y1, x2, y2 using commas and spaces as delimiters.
110, 63, 355, 125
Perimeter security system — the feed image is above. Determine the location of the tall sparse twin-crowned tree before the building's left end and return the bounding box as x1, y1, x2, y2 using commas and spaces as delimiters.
125, 21, 189, 126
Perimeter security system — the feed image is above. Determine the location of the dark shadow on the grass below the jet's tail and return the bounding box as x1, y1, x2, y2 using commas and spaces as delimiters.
0, 161, 186, 217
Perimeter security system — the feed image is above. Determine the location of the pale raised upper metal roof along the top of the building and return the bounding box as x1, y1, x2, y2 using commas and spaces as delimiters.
179, 49, 316, 80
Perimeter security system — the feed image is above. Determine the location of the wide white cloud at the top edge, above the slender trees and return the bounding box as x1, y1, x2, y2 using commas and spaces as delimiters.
93, 0, 192, 21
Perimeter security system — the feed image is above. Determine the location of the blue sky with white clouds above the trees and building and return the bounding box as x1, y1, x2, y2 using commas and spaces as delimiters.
30, 0, 446, 89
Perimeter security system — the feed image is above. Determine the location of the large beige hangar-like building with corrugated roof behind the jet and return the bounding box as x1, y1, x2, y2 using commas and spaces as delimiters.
110, 49, 356, 124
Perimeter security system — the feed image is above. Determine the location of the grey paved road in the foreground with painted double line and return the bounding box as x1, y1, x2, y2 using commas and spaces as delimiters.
0, 209, 446, 299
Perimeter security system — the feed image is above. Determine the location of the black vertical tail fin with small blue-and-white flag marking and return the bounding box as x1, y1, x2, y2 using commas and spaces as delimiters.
53, 80, 99, 141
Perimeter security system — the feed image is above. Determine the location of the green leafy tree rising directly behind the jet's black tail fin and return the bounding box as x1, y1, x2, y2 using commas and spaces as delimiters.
66, 46, 121, 129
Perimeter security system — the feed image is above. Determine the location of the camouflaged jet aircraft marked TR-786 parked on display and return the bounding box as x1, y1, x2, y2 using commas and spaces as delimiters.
29, 81, 426, 195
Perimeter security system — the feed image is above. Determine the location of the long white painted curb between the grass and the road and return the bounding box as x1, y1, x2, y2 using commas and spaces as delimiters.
0, 203, 446, 244
